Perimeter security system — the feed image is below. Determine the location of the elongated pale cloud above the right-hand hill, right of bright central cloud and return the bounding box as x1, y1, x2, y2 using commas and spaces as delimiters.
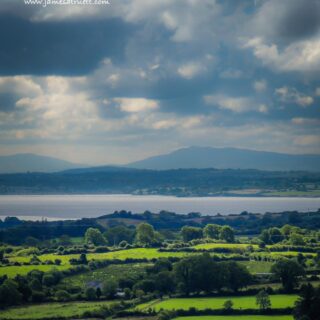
204, 95, 267, 113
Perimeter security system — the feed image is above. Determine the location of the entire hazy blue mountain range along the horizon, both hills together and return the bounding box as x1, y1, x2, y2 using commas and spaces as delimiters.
0, 147, 320, 173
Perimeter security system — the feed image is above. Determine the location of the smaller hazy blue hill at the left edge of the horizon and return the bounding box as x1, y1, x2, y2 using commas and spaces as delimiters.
0, 153, 80, 173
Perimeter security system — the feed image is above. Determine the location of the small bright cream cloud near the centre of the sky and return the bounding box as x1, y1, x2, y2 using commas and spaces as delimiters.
113, 98, 159, 113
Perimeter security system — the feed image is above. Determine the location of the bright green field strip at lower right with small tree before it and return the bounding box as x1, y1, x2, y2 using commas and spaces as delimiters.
137, 295, 298, 311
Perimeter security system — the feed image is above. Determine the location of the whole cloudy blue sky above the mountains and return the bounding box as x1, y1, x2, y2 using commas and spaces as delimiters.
0, 0, 320, 164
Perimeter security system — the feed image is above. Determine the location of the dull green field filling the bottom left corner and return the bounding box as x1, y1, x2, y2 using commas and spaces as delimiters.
1, 301, 116, 320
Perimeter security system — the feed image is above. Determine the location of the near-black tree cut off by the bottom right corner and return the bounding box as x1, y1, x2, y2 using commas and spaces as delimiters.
293, 283, 320, 320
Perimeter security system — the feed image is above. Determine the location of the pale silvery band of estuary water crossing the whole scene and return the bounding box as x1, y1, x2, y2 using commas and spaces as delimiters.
0, 195, 320, 220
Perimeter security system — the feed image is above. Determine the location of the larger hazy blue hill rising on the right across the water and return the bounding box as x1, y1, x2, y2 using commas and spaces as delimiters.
127, 147, 320, 172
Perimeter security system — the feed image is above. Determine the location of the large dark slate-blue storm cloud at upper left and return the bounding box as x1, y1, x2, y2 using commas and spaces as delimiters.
0, 15, 132, 75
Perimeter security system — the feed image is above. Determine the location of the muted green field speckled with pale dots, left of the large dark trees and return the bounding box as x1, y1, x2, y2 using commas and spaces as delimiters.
62, 263, 148, 288
